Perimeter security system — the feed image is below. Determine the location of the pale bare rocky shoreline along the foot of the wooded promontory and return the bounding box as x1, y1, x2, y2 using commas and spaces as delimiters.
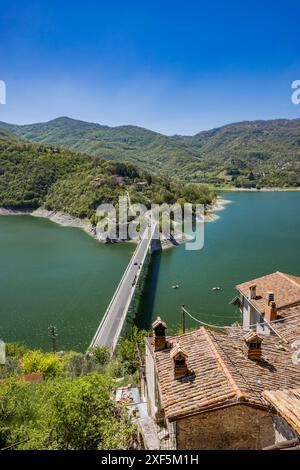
0, 198, 231, 249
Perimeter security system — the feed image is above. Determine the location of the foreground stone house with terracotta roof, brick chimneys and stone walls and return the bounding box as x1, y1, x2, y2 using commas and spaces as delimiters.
142, 294, 300, 449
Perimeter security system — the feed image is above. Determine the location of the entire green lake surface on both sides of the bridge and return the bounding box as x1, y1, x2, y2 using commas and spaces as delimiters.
0, 192, 300, 350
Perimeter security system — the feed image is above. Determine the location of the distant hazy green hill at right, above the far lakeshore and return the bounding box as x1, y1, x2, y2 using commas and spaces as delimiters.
177, 119, 300, 187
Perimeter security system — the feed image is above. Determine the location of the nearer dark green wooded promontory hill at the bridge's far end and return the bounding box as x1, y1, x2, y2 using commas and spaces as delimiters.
0, 129, 213, 217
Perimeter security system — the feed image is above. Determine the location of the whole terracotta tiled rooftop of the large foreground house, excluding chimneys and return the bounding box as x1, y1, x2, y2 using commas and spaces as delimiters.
147, 306, 300, 421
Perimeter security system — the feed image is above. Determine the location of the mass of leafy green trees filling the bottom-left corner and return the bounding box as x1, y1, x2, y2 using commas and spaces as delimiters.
0, 373, 134, 450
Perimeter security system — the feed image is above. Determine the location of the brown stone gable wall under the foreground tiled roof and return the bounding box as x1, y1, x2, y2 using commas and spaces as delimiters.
176, 405, 275, 450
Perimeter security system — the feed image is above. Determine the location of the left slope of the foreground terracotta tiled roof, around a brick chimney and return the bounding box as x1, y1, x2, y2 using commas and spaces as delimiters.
154, 329, 237, 418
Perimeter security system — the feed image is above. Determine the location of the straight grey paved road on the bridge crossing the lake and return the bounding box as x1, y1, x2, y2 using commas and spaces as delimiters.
90, 227, 156, 350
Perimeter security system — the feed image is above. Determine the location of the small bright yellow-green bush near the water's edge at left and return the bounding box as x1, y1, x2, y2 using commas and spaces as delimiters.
22, 351, 63, 378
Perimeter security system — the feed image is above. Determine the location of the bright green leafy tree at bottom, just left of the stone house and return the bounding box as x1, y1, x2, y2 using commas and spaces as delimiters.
46, 373, 132, 450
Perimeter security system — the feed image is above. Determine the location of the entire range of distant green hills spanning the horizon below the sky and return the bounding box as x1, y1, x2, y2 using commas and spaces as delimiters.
0, 117, 300, 187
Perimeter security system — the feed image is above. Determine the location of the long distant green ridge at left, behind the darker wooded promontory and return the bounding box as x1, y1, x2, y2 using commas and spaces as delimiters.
0, 117, 204, 181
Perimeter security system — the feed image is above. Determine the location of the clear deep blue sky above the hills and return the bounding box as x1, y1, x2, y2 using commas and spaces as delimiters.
0, 0, 300, 134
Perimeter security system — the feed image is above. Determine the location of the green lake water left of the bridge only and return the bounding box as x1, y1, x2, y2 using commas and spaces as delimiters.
0, 216, 134, 350
